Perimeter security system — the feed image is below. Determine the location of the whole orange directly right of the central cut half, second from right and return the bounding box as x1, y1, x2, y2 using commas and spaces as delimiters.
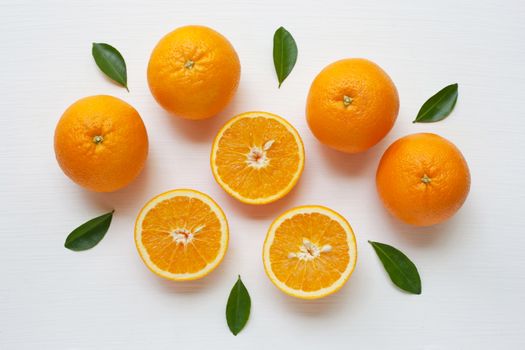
306, 58, 399, 153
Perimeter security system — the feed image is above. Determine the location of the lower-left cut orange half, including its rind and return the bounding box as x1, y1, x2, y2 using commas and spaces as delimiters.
135, 189, 229, 281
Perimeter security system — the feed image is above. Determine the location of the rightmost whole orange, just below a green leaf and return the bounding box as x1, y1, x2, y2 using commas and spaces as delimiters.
376, 133, 470, 226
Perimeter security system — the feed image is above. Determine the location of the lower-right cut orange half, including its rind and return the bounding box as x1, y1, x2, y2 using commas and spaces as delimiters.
263, 206, 357, 299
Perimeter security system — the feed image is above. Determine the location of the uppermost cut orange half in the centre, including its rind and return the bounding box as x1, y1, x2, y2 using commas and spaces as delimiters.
210, 112, 304, 204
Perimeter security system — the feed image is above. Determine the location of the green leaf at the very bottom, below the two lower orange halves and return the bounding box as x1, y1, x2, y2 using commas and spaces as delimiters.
226, 276, 252, 335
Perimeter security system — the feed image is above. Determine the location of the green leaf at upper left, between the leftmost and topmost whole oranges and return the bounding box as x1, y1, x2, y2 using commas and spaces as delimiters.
91, 43, 129, 92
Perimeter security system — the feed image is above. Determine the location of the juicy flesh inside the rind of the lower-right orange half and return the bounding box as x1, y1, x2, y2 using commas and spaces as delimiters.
270, 213, 350, 292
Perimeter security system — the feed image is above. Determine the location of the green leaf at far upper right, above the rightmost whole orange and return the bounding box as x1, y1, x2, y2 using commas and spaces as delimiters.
412, 83, 458, 123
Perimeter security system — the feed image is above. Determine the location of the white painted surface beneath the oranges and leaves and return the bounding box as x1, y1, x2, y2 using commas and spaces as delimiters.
0, 0, 525, 350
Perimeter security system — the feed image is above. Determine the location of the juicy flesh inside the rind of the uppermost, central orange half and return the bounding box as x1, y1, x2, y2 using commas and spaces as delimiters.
215, 117, 302, 199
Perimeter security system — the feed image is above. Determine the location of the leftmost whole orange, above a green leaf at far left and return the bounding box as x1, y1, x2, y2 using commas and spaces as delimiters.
55, 95, 148, 192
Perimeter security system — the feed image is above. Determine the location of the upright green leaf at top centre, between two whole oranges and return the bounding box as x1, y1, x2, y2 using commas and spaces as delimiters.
273, 27, 297, 87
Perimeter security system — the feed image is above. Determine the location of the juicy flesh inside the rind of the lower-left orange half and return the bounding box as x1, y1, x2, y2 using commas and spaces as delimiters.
142, 196, 221, 274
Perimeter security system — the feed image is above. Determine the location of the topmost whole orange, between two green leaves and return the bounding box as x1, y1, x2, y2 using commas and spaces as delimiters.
148, 25, 241, 119
